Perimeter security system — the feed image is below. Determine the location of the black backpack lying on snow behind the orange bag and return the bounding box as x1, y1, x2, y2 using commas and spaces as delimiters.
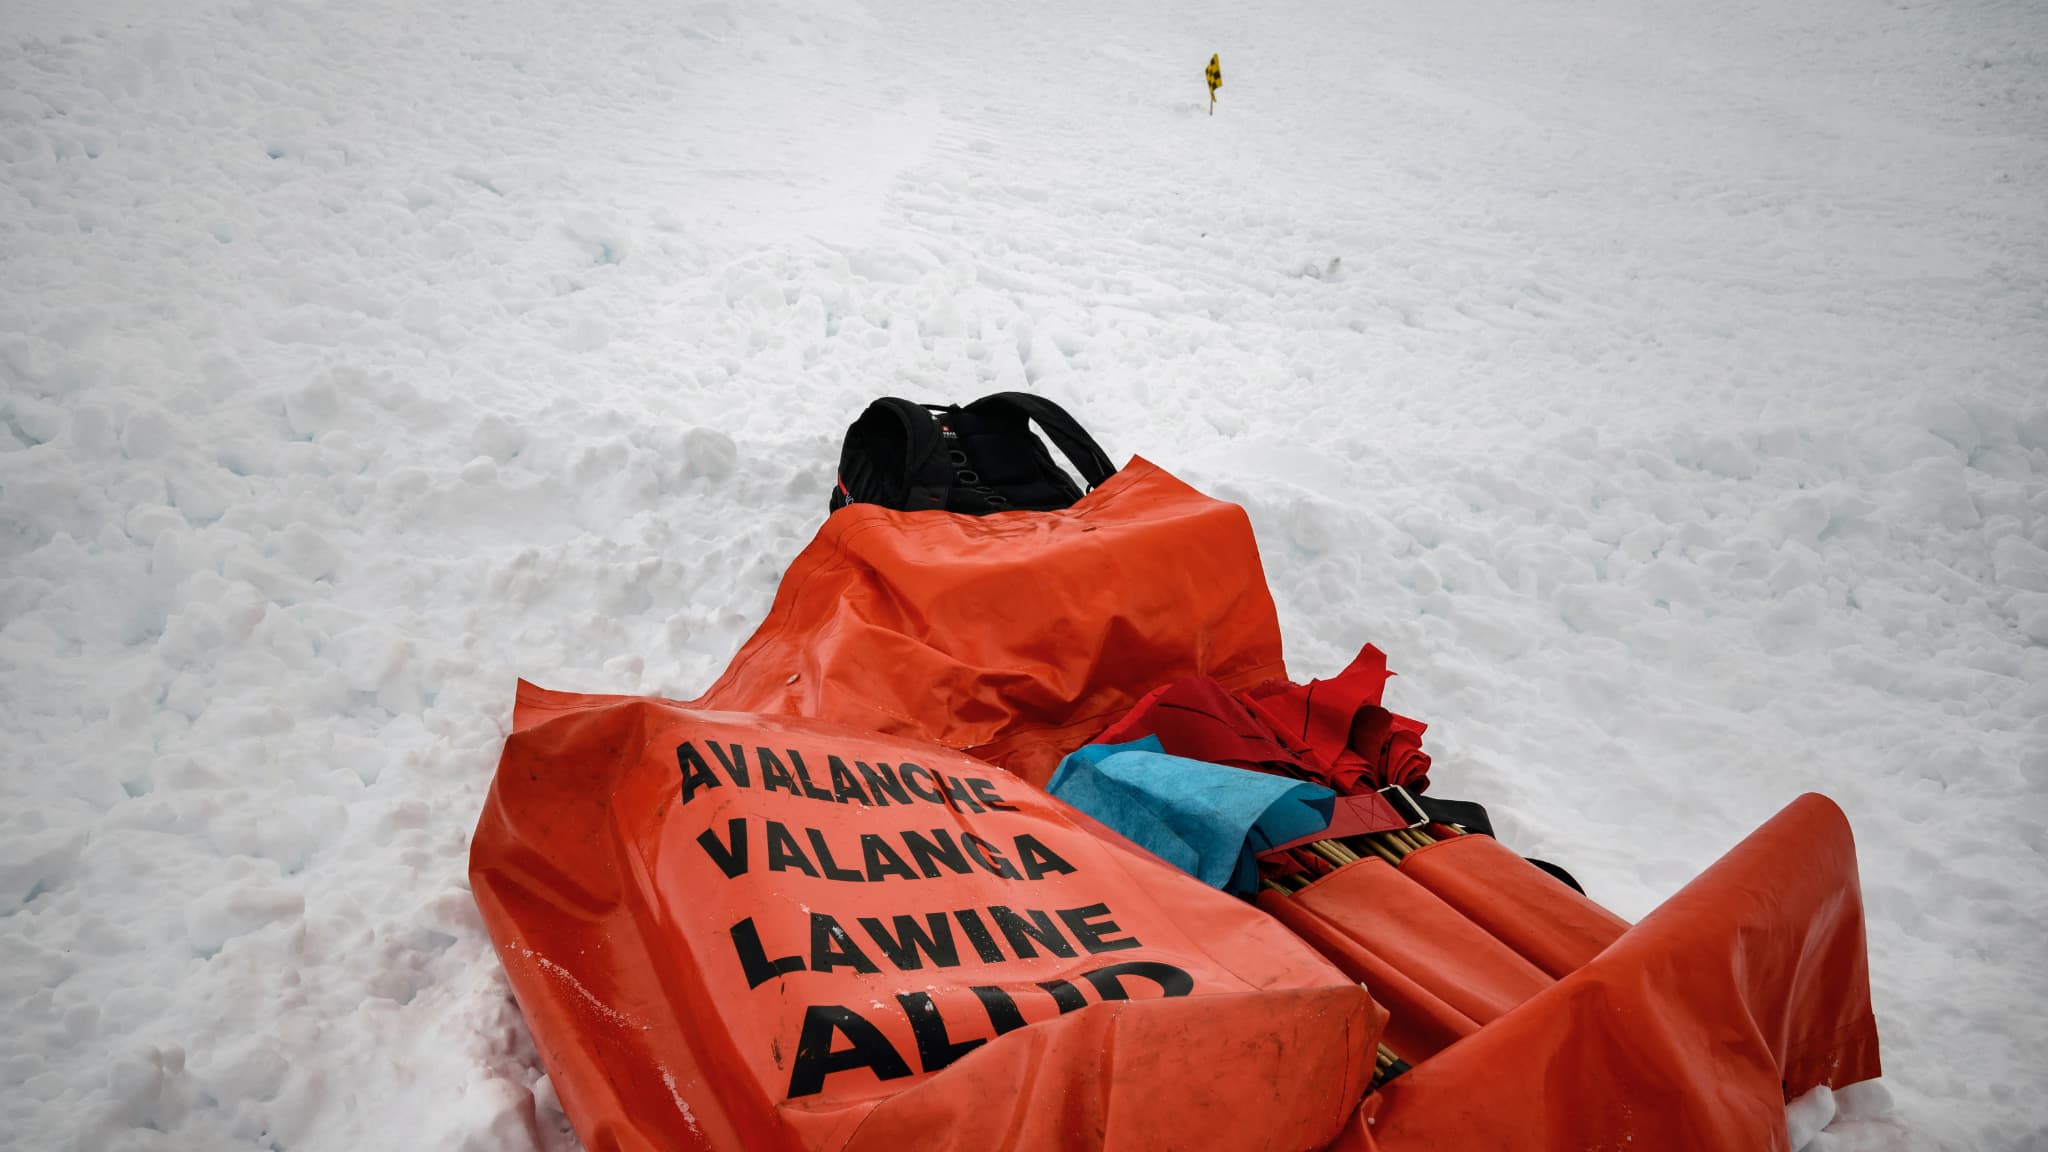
831, 392, 1116, 517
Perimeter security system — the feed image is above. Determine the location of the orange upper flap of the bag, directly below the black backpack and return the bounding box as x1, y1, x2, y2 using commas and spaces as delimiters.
692, 459, 1286, 787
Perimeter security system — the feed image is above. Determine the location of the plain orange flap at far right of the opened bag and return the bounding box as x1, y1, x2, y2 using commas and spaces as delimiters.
1333, 795, 1882, 1152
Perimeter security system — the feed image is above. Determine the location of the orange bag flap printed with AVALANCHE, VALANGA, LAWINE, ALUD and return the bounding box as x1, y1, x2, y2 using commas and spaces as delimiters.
471, 685, 1384, 1152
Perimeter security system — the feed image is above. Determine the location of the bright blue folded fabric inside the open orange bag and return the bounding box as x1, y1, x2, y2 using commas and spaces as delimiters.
1047, 736, 1337, 896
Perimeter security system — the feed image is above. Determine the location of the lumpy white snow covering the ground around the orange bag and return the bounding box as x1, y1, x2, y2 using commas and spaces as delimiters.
0, 0, 2048, 1152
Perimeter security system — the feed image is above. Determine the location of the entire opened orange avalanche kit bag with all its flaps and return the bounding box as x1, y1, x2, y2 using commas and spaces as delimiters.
471, 409, 1878, 1152
